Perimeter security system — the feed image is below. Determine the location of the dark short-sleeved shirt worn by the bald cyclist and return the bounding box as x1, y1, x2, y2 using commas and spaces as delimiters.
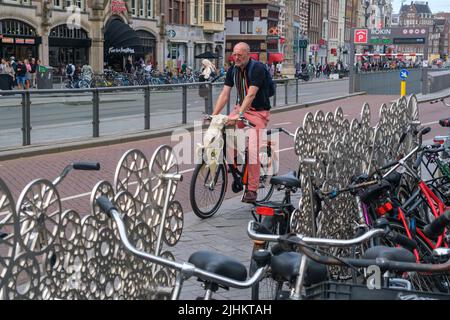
225, 62, 270, 111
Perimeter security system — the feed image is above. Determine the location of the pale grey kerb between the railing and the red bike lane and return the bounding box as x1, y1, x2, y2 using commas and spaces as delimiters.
0, 92, 366, 161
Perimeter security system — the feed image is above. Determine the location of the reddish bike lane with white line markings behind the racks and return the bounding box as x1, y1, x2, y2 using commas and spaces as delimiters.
0, 95, 450, 215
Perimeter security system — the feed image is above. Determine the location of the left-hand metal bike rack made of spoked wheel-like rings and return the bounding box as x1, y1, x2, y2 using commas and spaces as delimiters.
0, 146, 184, 300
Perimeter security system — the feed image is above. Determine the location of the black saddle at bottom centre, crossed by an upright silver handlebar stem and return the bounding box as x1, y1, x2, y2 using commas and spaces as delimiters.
270, 252, 328, 286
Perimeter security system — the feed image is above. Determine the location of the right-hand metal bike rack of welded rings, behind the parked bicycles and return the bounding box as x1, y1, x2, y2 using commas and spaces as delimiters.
291, 95, 420, 278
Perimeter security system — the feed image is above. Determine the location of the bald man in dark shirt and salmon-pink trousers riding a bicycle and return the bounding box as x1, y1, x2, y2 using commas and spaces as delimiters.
213, 42, 271, 203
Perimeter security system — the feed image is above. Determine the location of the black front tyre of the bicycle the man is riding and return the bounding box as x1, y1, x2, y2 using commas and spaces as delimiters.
189, 162, 228, 219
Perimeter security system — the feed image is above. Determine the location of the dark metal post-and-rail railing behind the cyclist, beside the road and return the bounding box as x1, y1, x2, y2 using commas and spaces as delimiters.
0, 78, 320, 146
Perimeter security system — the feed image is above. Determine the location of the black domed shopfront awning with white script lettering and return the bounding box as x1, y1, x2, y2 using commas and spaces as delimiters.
105, 19, 142, 55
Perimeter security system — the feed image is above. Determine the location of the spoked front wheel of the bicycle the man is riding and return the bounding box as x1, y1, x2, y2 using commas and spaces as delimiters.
190, 162, 228, 219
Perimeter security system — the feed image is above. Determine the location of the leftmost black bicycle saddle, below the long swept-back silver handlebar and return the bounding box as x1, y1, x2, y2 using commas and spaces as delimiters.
188, 251, 247, 281
